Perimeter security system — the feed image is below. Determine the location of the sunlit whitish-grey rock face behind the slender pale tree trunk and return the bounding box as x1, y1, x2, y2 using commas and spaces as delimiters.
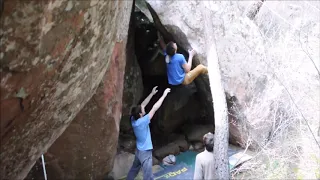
139, 0, 320, 147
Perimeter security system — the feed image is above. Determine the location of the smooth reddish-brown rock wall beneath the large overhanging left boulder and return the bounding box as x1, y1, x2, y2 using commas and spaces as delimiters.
47, 40, 129, 179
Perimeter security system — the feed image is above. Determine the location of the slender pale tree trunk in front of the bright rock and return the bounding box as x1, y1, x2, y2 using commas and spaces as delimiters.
202, 2, 230, 179
